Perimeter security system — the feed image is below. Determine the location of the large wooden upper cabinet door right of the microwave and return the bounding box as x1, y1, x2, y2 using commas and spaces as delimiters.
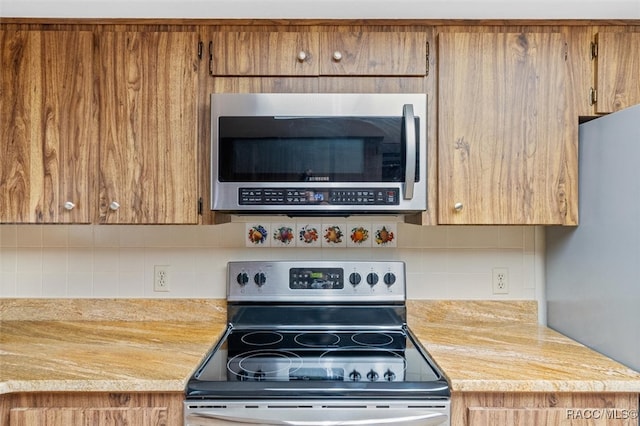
438, 33, 578, 225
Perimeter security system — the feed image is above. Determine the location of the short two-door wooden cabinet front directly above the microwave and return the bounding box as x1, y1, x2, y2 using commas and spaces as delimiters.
209, 31, 427, 76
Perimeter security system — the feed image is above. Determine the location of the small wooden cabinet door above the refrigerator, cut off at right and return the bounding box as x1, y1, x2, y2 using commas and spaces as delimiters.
596, 32, 640, 113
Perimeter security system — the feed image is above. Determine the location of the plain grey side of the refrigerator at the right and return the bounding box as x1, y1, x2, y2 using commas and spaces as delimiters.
546, 105, 640, 371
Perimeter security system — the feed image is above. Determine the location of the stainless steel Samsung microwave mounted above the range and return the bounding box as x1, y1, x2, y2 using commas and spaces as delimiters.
211, 93, 427, 216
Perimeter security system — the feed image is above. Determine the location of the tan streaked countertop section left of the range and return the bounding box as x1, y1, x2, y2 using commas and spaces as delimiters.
0, 299, 226, 394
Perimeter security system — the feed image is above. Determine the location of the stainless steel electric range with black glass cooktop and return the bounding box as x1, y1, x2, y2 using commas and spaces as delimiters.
184, 261, 450, 426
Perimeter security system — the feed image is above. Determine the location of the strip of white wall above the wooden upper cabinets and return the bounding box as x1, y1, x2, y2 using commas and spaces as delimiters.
0, 0, 640, 19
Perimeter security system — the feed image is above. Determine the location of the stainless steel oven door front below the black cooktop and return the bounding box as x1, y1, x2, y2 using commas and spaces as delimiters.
185, 401, 450, 426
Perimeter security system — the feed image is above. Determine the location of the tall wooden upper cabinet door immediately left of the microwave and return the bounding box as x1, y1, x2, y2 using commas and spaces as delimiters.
96, 32, 198, 224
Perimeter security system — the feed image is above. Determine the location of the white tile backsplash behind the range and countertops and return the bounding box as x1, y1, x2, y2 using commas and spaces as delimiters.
0, 222, 544, 308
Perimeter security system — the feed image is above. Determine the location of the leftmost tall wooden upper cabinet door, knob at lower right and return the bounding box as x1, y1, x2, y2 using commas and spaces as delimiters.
0, 31, 95, 223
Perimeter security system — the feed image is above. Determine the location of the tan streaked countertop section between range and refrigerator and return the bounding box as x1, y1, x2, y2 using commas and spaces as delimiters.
407, 301, 640, 393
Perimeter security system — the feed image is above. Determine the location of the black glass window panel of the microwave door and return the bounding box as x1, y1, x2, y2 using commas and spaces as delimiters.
217, 117, 420, 182
